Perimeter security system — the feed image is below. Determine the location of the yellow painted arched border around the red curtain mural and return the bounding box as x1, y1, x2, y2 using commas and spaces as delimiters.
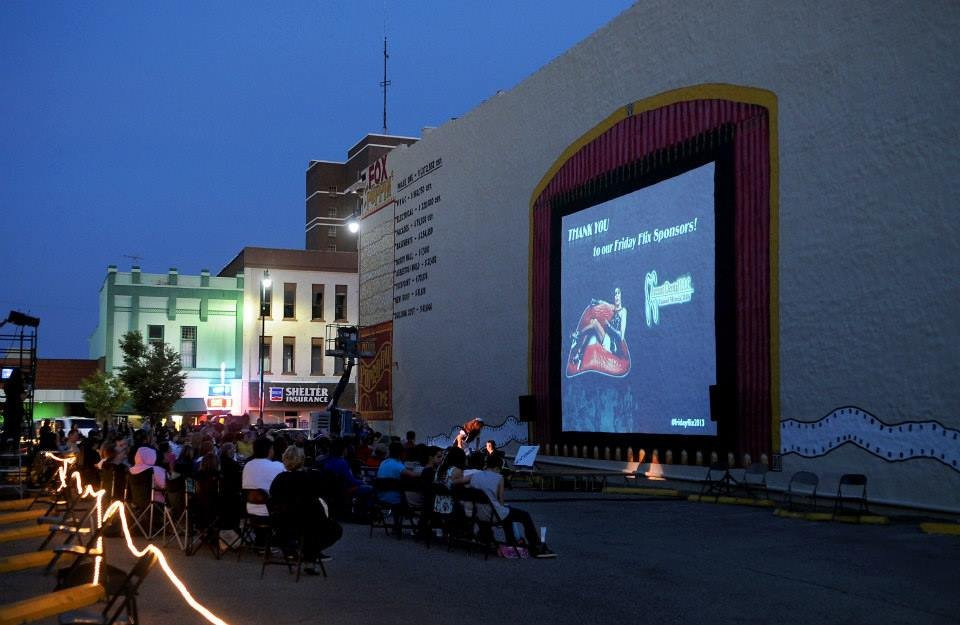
527, 83, 780, 453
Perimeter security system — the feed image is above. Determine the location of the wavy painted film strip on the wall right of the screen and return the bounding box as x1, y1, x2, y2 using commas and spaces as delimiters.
780, 406, 960, 471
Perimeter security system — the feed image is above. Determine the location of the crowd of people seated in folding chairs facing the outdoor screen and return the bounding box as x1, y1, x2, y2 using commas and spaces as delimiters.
30, 423, 552, 574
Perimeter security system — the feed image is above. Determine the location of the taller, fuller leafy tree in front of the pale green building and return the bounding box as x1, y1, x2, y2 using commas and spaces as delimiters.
120, 330, 186, 425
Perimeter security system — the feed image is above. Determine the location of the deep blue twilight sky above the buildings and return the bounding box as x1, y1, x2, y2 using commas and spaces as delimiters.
0, 0, 630, 358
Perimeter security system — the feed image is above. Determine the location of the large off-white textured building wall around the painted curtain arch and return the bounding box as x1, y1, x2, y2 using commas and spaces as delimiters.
362, 0, 960, 508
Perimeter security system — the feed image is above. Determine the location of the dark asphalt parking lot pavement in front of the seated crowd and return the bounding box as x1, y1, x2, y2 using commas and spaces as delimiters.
0, 490, 960, 625
